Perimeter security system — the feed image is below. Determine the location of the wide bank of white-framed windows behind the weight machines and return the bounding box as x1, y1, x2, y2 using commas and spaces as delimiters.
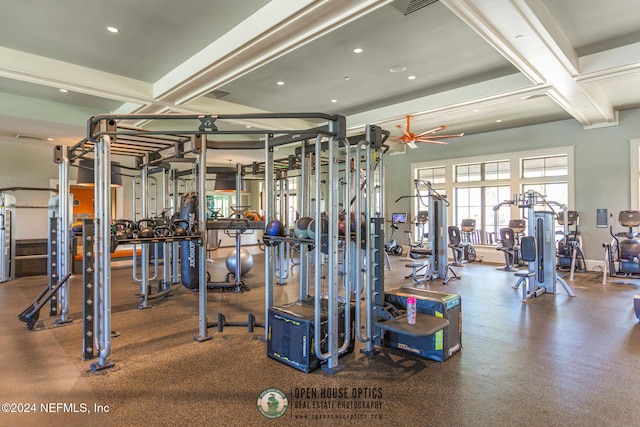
412, 144, 576, 245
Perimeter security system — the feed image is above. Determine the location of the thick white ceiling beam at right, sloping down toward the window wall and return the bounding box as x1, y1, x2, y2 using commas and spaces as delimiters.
441, 0, 618, 128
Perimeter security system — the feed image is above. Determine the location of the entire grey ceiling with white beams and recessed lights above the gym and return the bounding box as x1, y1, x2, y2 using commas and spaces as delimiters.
0, 0, 640, 163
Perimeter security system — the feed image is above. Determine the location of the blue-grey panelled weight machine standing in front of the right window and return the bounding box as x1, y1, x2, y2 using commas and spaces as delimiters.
505, 190, 575, 302
